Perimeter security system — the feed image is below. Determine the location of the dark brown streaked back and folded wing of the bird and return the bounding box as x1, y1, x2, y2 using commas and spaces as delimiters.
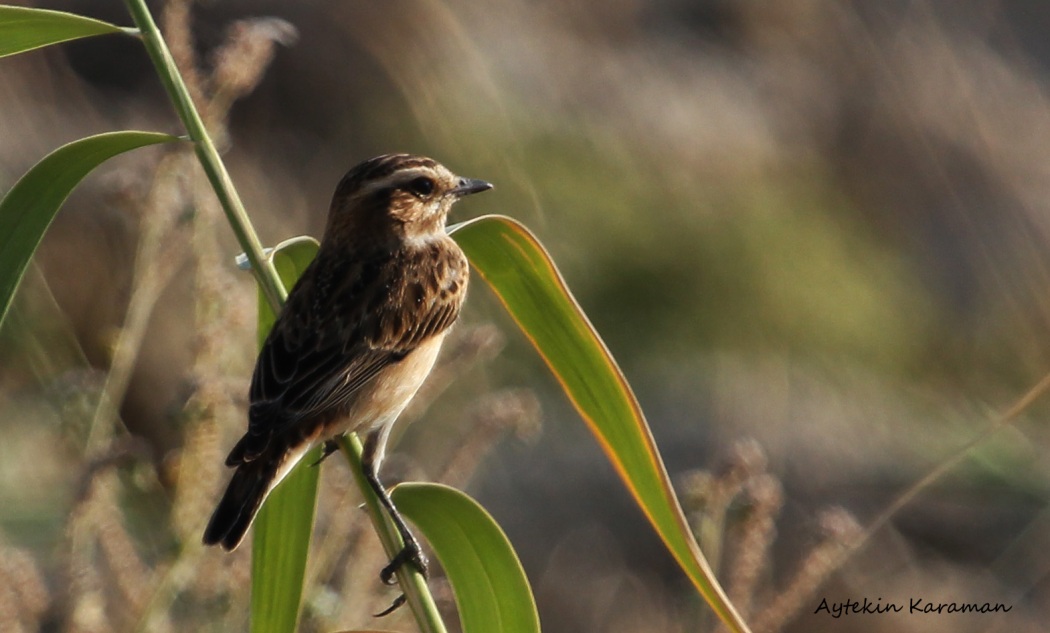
234, 240, 468, 464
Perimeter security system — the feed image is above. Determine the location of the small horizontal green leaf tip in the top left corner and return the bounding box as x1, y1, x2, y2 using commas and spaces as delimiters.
0, 6, 125, 57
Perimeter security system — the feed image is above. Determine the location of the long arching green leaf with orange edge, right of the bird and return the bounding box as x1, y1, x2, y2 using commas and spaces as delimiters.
450, 215, 748, 632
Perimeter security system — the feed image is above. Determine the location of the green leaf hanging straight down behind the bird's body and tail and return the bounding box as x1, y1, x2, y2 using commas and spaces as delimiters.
251, 237, 320, 633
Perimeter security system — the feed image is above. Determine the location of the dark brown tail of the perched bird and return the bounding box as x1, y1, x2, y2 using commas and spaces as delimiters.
204, 458, 279, 551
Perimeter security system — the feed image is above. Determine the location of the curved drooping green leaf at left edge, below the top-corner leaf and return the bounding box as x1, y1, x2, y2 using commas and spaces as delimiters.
0, 131, 179, 323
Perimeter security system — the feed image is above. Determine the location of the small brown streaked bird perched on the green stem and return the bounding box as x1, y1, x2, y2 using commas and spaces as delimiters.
204, 154, 492, 583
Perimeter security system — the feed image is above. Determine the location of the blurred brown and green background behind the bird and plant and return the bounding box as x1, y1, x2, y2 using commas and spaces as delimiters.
0, 0, 1050, 633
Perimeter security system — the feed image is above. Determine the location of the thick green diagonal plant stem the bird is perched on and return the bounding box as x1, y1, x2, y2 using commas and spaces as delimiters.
125, 0, 445, 633
